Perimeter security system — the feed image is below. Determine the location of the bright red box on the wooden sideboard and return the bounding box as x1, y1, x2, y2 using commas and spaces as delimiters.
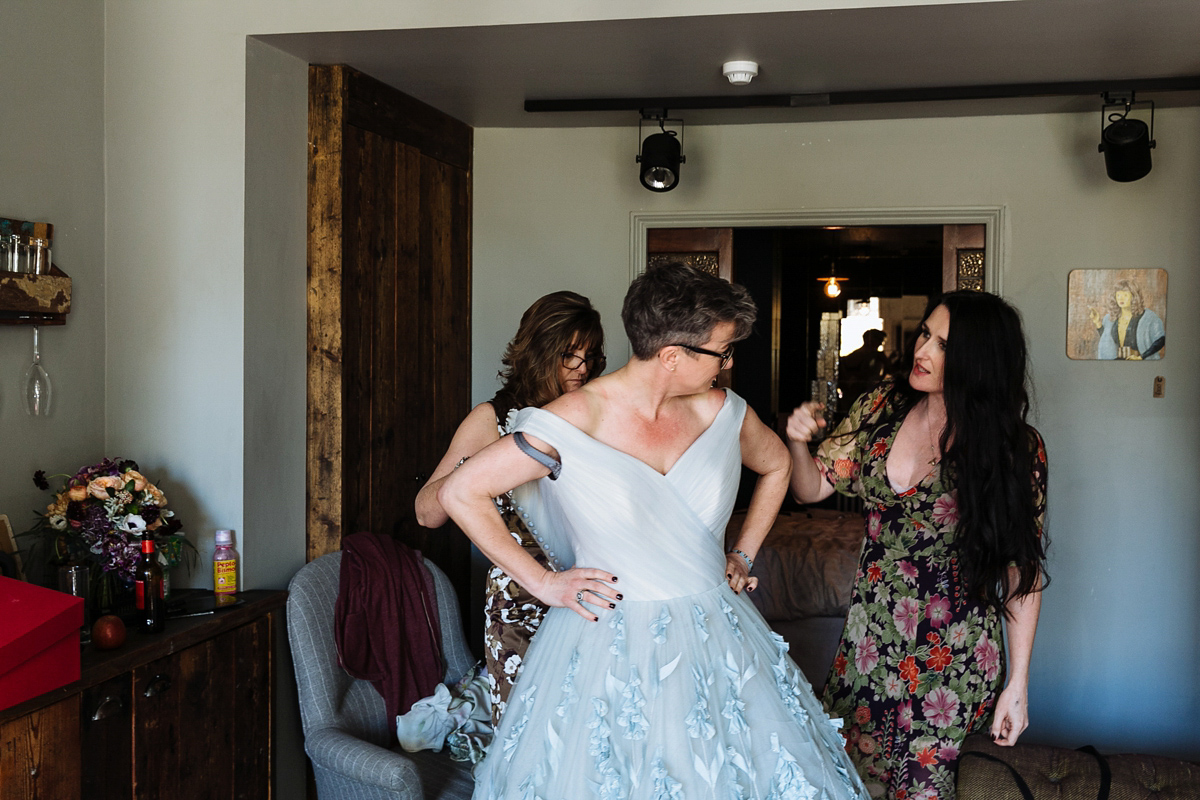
0, 577, 83, 710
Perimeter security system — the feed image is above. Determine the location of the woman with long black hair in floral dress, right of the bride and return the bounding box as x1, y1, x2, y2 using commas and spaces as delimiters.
787, 291, 1046, 800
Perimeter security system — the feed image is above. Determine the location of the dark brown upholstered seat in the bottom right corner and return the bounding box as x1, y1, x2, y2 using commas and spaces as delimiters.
958, 734, 1200, 800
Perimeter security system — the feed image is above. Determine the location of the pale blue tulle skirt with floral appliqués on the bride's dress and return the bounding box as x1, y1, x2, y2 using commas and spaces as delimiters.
474, 583, 868, 800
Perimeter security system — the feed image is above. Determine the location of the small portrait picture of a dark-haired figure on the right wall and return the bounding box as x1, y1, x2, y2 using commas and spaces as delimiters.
1067, 270, 1166, 361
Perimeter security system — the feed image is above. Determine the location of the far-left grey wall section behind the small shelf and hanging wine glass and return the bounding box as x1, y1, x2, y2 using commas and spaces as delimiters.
0, 0, 105, 563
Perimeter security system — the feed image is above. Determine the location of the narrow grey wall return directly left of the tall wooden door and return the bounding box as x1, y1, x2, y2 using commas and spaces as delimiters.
241, 40, 308, 798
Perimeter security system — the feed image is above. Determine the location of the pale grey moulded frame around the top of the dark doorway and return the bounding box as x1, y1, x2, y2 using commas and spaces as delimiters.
629, 205, 1008, 295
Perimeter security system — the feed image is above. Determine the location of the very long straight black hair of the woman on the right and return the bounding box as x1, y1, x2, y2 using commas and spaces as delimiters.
892, 291, 1049, 615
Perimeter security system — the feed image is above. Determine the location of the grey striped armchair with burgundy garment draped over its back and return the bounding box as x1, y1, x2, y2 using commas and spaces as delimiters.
288, 553, 474, 800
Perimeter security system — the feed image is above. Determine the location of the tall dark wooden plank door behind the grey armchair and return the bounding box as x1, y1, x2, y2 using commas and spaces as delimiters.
307, 66, 473, 608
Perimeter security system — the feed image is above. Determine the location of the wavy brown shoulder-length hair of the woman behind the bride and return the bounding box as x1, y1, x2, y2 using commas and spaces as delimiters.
492, 291, 605, 422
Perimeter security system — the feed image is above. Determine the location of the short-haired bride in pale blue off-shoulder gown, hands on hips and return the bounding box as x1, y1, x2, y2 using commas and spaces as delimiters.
438, 264, 868, 800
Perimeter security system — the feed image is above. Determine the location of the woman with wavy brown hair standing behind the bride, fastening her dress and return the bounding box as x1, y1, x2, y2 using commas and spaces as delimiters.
416, 291, 605, 724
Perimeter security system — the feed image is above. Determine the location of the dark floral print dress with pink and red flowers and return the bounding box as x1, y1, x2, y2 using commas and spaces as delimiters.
816, 386, 1046, 800
